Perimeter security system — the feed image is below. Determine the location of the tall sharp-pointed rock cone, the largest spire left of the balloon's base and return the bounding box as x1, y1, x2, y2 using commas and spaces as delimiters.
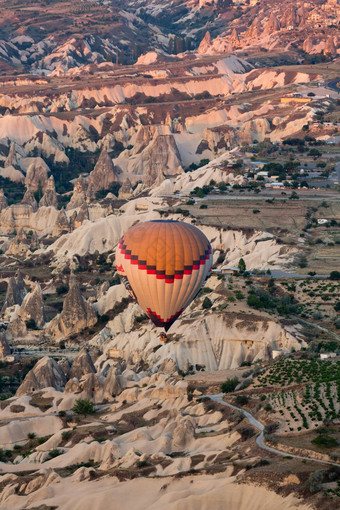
46, 274, 97, 339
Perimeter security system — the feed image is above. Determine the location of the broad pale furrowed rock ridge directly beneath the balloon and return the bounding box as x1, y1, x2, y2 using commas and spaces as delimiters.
98, 304, 305, 372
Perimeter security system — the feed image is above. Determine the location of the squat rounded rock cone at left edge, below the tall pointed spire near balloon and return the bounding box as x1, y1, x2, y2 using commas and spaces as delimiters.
16, 356, 66, 396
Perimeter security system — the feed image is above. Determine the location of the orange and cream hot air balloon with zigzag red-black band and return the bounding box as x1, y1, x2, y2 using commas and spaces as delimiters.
116, 220, 213, 339
